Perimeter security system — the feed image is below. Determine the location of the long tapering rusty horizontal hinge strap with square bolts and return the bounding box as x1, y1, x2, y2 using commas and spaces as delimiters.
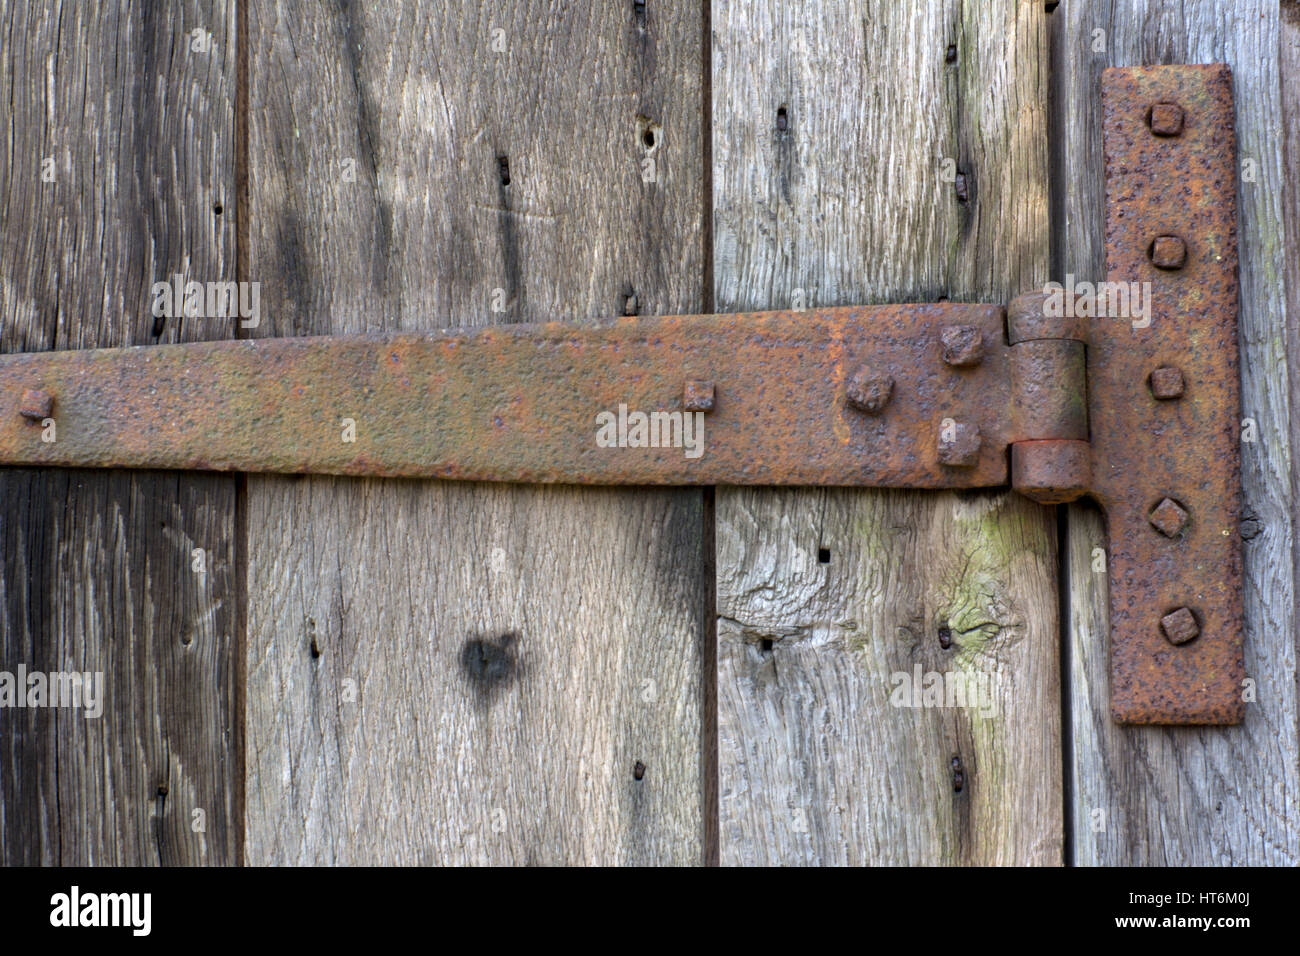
0, 303, 1014, 488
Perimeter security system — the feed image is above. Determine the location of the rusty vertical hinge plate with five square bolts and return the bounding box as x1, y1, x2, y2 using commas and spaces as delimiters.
1088, 65, 1245, 723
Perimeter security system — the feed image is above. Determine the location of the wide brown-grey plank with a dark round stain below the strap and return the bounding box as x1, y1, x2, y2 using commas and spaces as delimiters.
247, 0, 707, 864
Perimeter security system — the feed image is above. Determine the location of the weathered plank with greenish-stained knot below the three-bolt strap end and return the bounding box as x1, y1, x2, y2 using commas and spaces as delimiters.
712, 0, 1063, 864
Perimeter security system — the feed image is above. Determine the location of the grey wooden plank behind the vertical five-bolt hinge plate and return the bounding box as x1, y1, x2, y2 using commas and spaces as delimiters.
1053, 0, 1300, 865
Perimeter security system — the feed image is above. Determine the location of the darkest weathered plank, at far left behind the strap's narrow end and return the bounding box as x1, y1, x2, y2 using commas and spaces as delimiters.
0, 0, 242, 866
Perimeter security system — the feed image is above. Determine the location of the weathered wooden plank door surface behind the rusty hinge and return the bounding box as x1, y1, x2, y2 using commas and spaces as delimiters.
0, 0, 1300, 865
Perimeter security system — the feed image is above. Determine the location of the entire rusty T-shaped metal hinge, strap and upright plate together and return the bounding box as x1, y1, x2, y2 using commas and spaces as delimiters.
0, 66, 1244, 723
